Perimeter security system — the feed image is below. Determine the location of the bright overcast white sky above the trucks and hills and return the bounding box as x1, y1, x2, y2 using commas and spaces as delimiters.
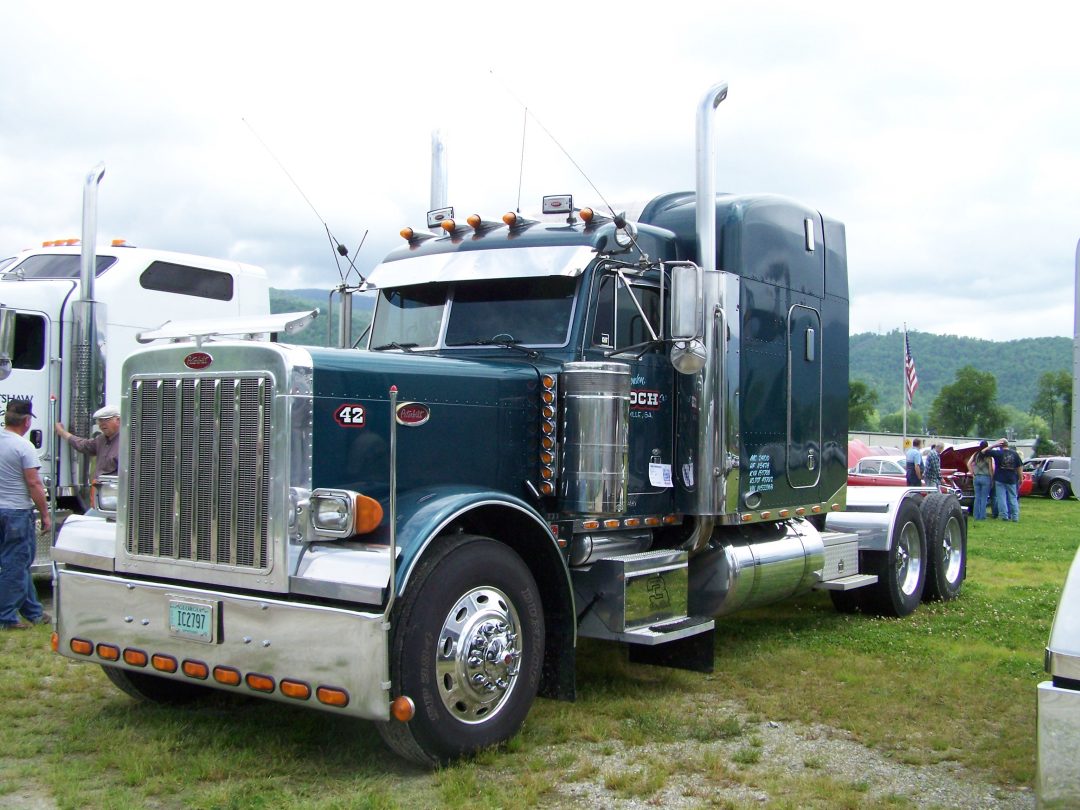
0, 0, 1080, 340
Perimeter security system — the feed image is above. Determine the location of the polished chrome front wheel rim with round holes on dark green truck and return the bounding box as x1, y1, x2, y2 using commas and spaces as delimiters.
435, 586, 522, 724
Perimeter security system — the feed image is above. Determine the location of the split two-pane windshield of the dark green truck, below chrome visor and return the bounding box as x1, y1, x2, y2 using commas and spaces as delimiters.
370, 275, 578, 349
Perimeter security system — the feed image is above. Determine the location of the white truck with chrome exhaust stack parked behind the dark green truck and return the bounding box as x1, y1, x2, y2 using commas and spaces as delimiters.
0, 165, 270, 570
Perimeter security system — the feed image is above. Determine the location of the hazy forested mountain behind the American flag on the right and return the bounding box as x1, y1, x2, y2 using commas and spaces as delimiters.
848, 329, 1072, 415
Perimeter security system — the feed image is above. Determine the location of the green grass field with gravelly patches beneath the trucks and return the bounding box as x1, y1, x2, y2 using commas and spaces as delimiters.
0, 498, 1080, 809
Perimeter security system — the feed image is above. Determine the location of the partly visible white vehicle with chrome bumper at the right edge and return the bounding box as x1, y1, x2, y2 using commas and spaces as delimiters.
1035, 551, 1080, 808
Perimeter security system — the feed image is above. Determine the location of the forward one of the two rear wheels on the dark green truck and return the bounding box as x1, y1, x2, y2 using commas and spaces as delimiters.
866, 498, 927, 617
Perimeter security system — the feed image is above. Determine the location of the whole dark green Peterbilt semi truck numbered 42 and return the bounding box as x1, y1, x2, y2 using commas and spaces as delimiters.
54, 85, 966, 762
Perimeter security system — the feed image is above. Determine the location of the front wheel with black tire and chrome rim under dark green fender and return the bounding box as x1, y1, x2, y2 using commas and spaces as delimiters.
376, 535, 544, 766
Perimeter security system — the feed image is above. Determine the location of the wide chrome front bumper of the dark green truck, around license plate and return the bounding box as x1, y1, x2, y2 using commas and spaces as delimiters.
54, 568, 390, 720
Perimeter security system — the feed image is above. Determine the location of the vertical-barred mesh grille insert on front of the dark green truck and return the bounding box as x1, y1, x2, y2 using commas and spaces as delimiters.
126, 376, 273, 570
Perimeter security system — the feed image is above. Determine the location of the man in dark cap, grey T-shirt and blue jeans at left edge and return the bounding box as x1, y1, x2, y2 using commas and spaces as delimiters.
0, 400, 52, 630
